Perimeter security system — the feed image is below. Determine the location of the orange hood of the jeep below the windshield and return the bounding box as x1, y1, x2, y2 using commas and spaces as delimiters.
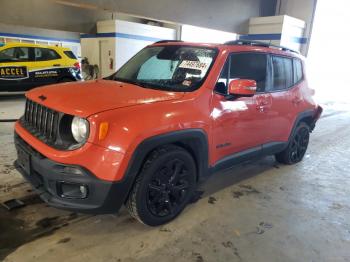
26, 80, 184, 117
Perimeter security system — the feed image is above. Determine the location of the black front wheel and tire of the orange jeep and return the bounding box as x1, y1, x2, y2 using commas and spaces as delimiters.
126, 145, 197, 226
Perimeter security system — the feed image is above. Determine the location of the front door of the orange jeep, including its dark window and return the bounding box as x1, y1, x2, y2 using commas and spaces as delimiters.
212, 53, 271, 162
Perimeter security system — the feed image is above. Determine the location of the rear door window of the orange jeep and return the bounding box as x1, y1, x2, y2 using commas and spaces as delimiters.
272, 56, 294, 91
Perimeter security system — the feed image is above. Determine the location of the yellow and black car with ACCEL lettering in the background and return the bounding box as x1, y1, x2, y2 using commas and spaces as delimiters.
0, 43, 82, 92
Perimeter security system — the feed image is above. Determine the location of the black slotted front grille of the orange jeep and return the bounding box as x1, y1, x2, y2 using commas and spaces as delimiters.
21, 99, 60, 145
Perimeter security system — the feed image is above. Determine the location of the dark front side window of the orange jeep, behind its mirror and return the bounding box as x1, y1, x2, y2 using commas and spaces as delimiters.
215, 53, 267, 94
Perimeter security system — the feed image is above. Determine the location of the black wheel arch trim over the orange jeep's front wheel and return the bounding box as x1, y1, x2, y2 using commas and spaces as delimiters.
122, 129, 209, 203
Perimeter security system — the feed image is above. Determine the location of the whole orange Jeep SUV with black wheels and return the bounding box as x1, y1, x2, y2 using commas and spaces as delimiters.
15, 40, 322, 226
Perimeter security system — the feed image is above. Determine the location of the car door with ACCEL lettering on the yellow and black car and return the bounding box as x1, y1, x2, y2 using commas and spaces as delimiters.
0, 47, 33, 92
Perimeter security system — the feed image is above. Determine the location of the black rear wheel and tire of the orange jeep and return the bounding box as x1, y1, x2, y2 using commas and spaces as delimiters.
275, 122, 310, 165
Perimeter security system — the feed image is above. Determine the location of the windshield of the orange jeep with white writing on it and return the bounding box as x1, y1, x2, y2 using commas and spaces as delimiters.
112, 45, 217, 92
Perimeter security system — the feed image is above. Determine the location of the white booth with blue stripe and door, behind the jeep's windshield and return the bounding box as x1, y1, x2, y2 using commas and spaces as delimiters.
81, 20, 177, 77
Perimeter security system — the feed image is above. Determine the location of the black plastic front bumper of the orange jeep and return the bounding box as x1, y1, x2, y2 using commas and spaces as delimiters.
14, 133, 132, 214
